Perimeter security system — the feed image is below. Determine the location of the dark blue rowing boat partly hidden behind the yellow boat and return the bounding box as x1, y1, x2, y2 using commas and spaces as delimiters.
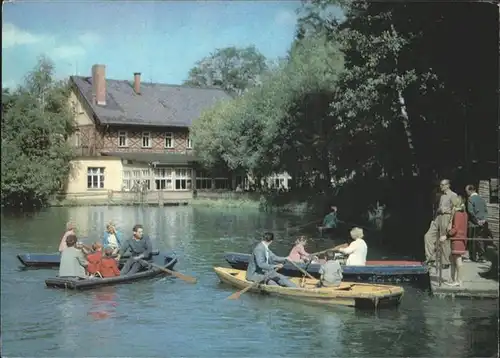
224, 252, 429, 284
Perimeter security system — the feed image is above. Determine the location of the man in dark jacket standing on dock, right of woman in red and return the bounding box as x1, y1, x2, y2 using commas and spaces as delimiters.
465, 184, 489, 262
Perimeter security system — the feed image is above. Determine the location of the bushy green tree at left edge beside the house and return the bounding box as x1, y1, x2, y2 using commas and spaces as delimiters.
1, 57, 73, 207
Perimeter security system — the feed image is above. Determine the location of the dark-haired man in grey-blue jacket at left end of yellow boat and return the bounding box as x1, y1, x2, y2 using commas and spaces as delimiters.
246, 232, 297, 287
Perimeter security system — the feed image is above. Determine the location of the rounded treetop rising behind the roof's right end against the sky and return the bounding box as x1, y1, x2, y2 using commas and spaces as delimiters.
184, 46, 268, 95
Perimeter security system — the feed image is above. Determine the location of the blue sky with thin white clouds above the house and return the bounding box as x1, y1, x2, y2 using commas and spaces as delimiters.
2, 0, 301, 87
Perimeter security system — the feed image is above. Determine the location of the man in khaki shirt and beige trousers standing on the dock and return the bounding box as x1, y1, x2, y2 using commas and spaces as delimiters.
424, 179, 457, 269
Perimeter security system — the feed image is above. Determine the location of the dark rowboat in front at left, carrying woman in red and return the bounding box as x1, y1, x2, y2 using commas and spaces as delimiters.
45, 253, 177, 290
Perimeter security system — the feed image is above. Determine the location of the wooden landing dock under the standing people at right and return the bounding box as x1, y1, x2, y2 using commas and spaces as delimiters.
429, 262, 498, 299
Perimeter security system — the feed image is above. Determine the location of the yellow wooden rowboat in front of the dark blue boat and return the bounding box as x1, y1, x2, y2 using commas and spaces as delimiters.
214, 267, 404, 309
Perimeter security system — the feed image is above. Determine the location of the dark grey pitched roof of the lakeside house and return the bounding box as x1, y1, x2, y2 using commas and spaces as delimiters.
70, 76, 232, 127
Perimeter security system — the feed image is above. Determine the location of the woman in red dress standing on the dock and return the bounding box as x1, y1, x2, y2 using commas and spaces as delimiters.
439, 196, 467, 286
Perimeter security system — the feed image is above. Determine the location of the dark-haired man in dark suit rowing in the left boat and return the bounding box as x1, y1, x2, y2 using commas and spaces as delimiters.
116, 224, 153, 276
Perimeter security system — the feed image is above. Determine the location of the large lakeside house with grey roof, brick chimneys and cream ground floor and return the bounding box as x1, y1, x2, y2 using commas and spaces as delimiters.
65, 65, 288, 201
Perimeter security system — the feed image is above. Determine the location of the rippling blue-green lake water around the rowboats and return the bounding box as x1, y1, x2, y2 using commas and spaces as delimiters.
1, 207, 498, 357
